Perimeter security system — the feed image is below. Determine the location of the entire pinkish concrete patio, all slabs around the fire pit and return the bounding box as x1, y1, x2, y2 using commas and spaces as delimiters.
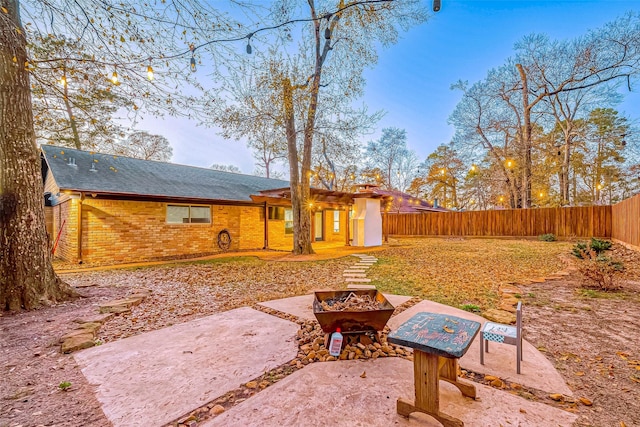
74, 295, 576, 427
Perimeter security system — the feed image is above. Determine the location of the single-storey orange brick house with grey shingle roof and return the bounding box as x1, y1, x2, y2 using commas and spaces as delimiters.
41, 145, 384, 263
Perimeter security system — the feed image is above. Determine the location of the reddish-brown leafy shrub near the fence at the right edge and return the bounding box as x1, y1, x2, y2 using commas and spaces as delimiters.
574, 248, 624, 291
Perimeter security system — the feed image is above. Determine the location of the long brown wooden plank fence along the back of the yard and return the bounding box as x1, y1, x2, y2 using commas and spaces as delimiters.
383, 206, 612, 241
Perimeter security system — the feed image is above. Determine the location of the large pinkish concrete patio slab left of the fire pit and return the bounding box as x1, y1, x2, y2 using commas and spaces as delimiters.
74, 307, 298, 426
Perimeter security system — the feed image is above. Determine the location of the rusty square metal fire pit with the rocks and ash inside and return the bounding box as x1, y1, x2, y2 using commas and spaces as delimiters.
313, 289, 395, 334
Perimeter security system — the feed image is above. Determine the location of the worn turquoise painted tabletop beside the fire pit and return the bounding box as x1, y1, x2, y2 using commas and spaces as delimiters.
387, 312, 480, 358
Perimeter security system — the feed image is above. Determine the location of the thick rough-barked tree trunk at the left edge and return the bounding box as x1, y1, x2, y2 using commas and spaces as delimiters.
0, 0, 75, 310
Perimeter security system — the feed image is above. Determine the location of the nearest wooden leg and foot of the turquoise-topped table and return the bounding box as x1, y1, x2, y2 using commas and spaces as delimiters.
397, 349, 464, 427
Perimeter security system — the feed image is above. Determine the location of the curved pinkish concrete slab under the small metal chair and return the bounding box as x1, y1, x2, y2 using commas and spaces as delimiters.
388, 301, 573, 396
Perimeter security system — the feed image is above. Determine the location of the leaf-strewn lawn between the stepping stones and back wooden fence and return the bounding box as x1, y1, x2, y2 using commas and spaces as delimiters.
367, 238, 571, 308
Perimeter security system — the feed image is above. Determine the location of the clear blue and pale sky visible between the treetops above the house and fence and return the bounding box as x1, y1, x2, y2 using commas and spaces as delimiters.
131, 0, 640, 174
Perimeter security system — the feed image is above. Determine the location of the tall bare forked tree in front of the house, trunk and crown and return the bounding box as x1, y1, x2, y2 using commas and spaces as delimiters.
216, 0, 426, 254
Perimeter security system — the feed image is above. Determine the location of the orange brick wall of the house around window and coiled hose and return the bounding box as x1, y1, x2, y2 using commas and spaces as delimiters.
53, 197, 272, 263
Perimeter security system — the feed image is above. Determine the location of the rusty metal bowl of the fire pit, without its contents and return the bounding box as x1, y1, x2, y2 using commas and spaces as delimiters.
313, 289, 395, 334
